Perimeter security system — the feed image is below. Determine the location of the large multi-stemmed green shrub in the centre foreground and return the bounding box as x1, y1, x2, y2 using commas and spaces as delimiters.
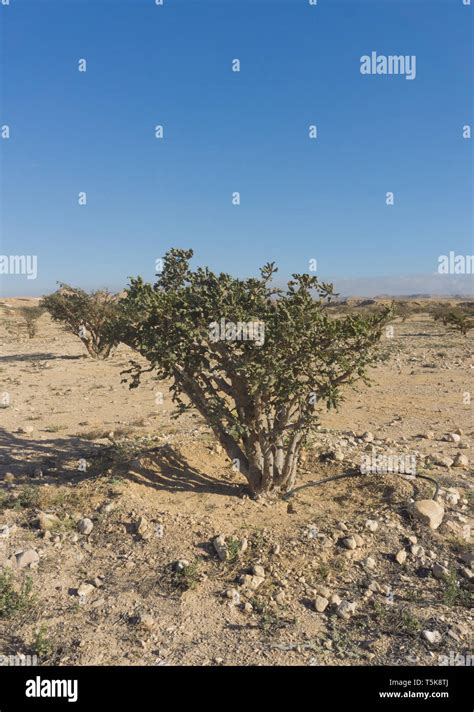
121, 249, 391, 494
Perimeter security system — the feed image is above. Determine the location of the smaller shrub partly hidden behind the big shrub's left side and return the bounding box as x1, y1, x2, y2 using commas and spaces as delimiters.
40, 284, 120, 359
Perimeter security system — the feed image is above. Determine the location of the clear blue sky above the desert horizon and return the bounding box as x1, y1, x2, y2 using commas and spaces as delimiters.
0, 0, 474, 296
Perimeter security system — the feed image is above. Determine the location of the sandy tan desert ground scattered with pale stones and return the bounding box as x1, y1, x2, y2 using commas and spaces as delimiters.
0, 299, 474, 665
